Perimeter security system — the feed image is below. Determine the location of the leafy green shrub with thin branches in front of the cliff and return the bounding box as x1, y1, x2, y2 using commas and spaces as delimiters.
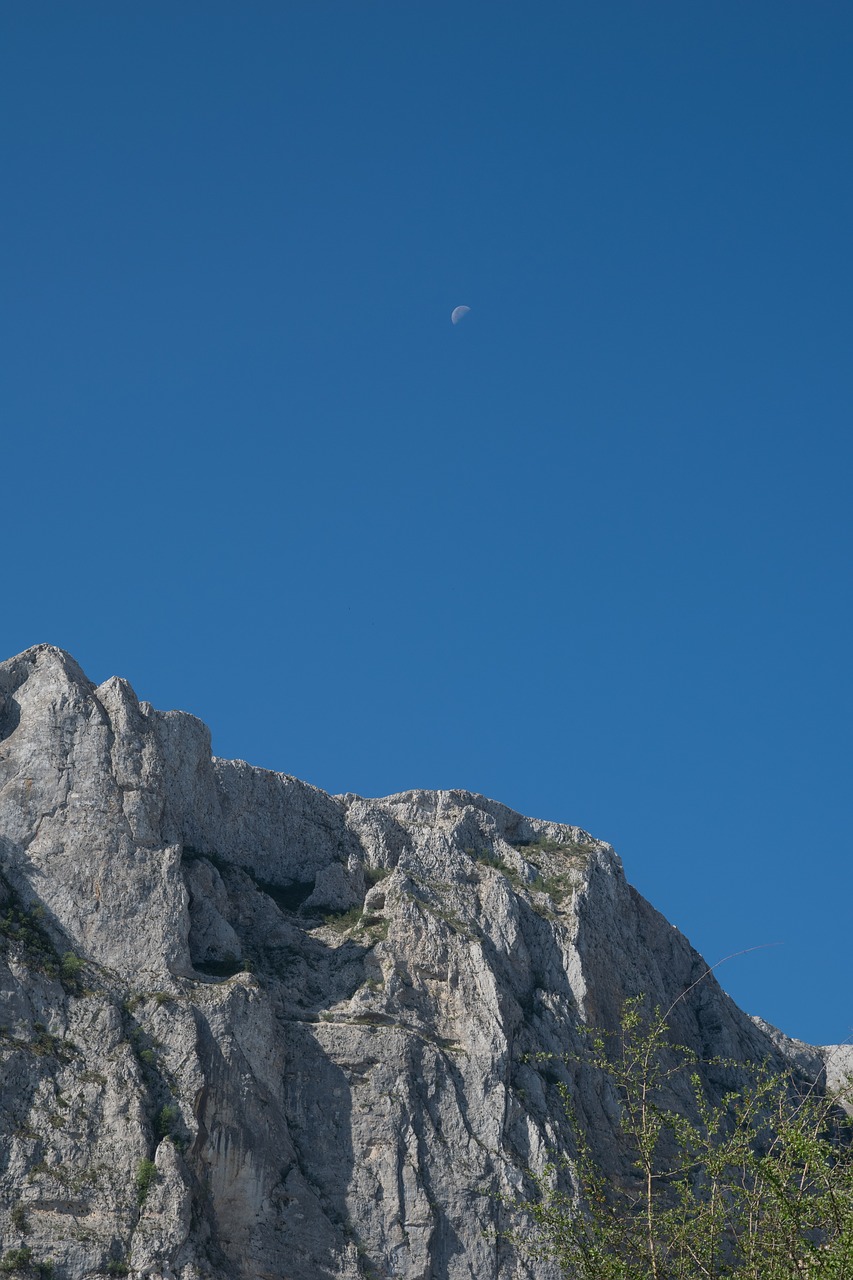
512, 1001, 853, 1280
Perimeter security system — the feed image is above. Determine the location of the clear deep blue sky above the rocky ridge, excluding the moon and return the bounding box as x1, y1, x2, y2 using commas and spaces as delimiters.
0, 0, 853, 1041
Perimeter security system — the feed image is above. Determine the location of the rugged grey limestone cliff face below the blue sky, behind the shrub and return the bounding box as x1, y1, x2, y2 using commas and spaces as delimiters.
0, 645, 822, 1280
